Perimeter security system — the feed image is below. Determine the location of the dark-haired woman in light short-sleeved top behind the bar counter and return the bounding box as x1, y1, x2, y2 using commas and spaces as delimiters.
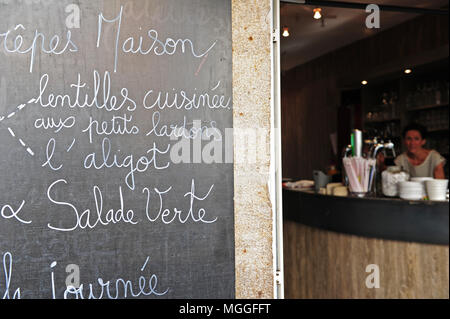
394, 124, 446, 179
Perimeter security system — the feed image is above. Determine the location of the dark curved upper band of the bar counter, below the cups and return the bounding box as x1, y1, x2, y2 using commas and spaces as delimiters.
283, 188, 449, 245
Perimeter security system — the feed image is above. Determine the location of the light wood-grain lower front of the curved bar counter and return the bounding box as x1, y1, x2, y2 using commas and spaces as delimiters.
283, 189, 449, 299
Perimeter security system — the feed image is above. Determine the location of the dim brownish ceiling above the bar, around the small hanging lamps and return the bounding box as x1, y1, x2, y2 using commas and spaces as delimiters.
280, 0, 449, 71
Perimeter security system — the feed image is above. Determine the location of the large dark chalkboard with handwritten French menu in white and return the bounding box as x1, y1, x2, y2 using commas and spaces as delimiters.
0, 0, 235, 299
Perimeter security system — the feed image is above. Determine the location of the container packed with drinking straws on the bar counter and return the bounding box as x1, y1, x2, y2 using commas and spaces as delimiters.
342, 157, 376, 197
